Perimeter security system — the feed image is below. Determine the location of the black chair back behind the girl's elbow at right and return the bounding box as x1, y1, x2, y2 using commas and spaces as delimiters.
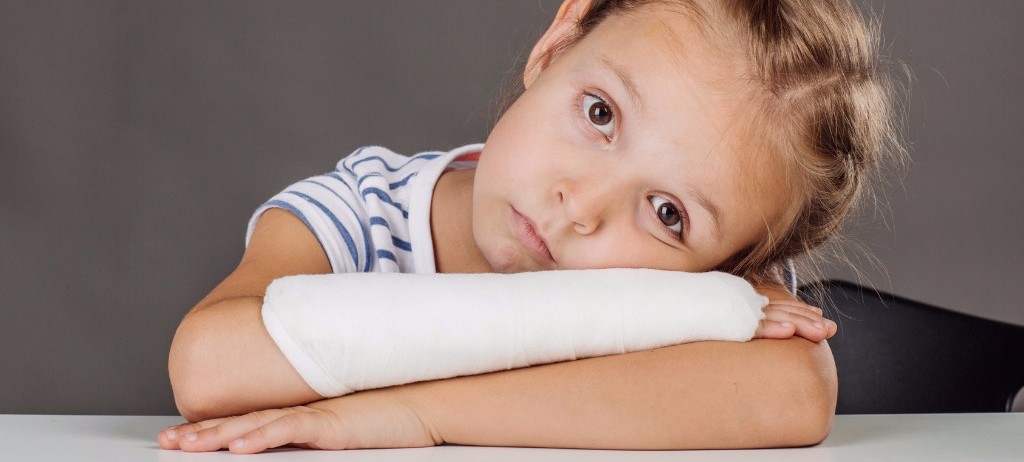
802, 281, 1024, 414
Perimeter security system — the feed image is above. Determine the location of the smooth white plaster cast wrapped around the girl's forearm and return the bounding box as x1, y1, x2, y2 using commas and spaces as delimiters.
262, 268, 768, 396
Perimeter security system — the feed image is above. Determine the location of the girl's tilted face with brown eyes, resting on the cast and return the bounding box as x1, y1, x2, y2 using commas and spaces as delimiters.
473, 2, 791, 272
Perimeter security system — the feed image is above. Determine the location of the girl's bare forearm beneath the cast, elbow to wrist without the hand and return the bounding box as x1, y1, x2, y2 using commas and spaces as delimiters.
391, 338, 837, 450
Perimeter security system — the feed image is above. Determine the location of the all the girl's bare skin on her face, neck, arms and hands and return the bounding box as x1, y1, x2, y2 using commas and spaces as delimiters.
158, 0, 836, 453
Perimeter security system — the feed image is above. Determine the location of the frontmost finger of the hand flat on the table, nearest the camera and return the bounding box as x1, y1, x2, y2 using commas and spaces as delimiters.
227, 412, 329, 454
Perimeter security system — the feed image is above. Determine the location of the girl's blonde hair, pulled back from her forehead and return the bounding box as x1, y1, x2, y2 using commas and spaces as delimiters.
524, 0, 906, 283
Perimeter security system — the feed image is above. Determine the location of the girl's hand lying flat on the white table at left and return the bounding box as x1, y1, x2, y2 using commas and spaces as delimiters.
157, 389, 442, 454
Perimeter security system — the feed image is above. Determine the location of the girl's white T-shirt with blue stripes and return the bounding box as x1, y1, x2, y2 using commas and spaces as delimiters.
246, 144, 483, 272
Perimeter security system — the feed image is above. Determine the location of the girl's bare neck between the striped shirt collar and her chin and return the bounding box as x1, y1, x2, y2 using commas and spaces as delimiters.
430, 169, 493, 272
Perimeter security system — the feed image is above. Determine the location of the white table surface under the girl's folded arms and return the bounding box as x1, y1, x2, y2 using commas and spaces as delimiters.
0, 413, 1024, 462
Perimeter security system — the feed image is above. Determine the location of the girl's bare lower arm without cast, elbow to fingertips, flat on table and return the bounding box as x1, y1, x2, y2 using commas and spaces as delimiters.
158, 340, 836, 454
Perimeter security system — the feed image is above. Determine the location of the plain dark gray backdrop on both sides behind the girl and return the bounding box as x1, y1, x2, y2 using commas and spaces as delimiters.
0, 0, 1024, 414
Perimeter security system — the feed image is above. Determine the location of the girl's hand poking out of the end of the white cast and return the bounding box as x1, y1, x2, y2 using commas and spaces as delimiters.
754, 287, 838, 343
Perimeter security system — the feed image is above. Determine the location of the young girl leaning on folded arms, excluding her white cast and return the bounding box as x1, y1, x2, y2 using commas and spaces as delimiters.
158, 0, 892, 453
